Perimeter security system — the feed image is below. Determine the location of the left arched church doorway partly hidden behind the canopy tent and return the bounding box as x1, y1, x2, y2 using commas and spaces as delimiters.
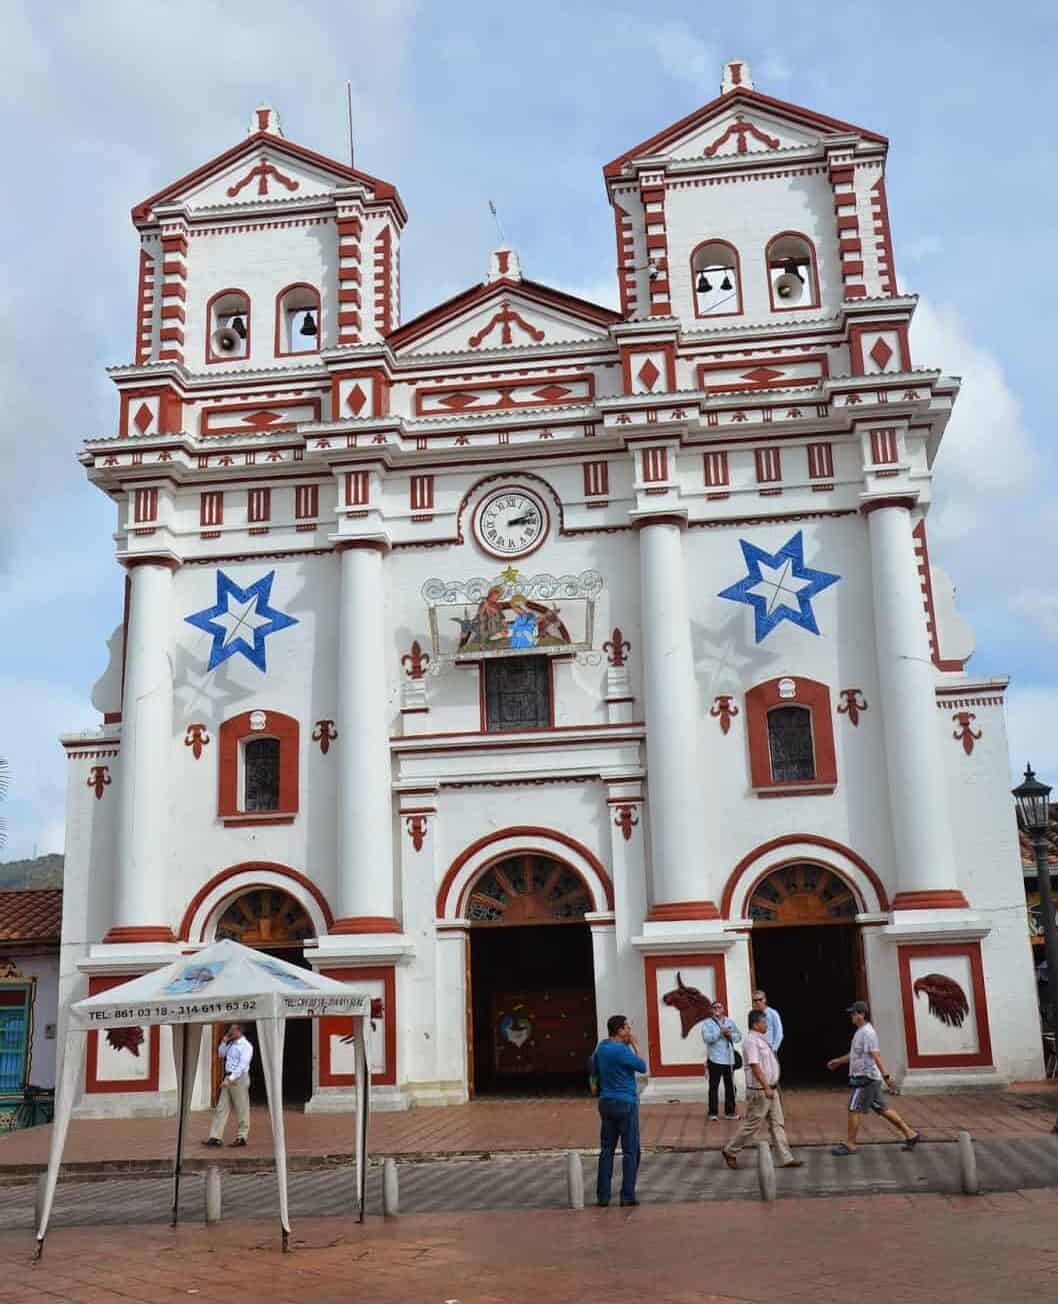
213, 887, 316, 1104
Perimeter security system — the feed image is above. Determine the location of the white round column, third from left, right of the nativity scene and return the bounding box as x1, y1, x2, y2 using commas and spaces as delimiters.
639, 516, 718, 921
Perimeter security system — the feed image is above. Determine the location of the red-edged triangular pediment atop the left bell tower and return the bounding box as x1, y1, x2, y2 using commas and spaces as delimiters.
132, 132, 403, 222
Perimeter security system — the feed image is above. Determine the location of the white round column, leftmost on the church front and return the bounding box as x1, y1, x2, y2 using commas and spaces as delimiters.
112, 558, 175, 941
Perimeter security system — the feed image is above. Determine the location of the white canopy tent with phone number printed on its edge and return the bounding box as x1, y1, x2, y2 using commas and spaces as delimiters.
37, 941, 370, 1258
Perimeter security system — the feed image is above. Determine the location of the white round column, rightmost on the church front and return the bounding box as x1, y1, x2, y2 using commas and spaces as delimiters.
864, 499, 965, 909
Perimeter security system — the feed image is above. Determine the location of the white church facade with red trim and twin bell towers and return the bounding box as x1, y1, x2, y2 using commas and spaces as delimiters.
61, 63, 1040, 1114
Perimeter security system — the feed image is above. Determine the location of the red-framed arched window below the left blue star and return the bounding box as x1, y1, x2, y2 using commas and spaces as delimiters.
217, 711, 299, 824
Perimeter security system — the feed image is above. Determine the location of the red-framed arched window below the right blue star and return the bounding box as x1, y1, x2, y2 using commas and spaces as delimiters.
746, 675, 838, 797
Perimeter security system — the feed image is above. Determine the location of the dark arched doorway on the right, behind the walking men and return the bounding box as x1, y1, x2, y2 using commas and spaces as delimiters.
751, 863, 866, 1084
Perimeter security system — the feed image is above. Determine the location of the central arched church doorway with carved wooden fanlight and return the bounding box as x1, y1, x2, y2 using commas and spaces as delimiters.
464, 852, 596, 1094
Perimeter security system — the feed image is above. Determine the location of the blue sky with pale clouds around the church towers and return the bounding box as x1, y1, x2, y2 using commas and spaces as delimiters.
0, 0, 1058, 857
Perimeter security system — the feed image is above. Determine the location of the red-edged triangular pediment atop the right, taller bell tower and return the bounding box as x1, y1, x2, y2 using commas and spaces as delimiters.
604, 87, 886, 177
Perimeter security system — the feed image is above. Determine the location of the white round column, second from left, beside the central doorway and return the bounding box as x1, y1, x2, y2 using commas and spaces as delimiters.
331, 540, 399, 932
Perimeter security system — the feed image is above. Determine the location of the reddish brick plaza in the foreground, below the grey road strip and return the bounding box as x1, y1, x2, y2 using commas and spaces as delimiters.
0, 1191, 1058, 1304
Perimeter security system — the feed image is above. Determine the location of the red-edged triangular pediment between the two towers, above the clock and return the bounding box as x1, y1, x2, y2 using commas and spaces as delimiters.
387, 278, 621, 353
